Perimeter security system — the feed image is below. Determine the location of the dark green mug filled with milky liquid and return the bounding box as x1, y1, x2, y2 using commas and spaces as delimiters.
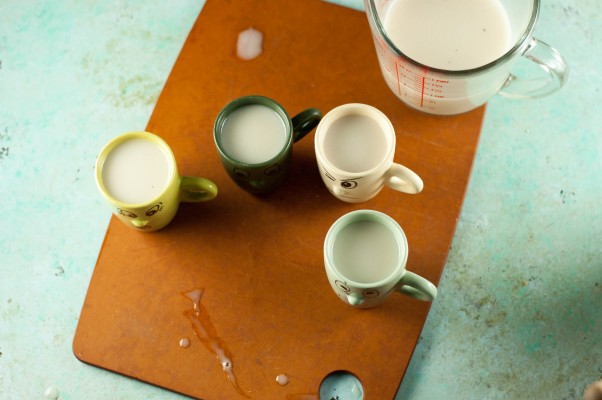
213, 96, 322, 194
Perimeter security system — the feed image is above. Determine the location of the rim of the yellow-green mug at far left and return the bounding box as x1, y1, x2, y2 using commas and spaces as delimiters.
94, 131, 178, 209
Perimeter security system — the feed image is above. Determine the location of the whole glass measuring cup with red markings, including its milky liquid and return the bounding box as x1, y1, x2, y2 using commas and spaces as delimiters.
364, 0, 568, 115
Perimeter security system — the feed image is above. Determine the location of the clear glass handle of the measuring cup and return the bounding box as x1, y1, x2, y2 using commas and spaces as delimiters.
500, 38, 569, 99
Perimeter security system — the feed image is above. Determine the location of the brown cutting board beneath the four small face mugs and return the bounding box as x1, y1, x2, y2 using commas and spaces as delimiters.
73, 0, 484, 400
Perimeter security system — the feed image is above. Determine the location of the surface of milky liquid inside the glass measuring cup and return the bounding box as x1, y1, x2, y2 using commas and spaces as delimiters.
384, 0, 511, 71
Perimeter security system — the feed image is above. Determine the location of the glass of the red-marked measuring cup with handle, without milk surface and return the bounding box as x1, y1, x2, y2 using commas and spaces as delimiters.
364, 0, 568, 115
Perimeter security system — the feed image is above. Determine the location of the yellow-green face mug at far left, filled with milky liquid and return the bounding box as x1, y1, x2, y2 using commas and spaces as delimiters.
95, 132, 217, 231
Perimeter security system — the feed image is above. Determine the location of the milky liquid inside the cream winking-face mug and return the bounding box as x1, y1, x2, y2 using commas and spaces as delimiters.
324, 114, 387, 172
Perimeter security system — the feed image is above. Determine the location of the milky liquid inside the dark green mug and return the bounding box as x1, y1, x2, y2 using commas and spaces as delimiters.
221, 104, 287, 164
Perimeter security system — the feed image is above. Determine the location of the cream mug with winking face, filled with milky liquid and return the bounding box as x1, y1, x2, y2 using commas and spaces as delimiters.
314, 103, 424, 203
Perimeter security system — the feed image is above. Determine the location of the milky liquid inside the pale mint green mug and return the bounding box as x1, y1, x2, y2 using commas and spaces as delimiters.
333, 220, 399, 283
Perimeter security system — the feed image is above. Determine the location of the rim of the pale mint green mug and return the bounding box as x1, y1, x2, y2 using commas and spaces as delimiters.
324, 209, 409, 289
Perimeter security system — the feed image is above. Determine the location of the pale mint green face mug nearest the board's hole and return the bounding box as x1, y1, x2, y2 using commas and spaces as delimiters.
324, 210, 437, 308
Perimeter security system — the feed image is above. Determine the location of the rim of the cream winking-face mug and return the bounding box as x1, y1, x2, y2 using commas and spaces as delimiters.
314, 103, 397, 177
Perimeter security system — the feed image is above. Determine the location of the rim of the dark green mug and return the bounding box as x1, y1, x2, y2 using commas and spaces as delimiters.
213, 95, 293, 169
